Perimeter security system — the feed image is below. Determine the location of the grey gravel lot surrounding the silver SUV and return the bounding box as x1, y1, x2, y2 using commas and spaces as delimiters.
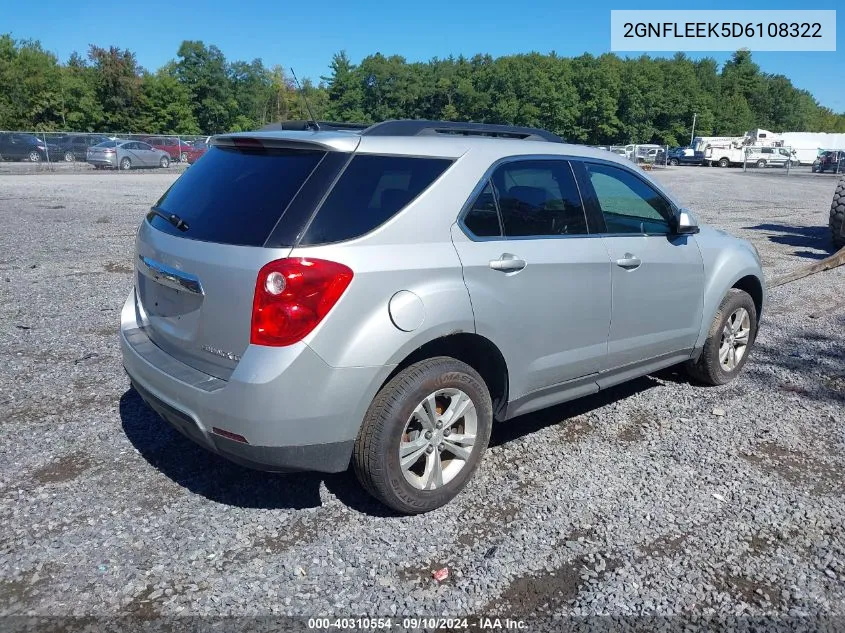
0, 168, 845, 629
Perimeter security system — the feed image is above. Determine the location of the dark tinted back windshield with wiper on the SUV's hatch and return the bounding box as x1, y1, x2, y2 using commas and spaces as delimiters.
148, 147, 325, 246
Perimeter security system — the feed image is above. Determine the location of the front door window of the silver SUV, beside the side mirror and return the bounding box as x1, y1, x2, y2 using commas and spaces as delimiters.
584, 163, 672, 235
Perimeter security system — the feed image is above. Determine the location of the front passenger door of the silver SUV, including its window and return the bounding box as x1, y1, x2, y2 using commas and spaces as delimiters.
576, 161, 704, 369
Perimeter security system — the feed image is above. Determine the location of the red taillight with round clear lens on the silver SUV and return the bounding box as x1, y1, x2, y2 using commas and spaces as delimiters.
249, 258, 352, 347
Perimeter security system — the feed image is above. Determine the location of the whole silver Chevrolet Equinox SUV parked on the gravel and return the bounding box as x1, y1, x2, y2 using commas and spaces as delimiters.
120, 121, 765, 513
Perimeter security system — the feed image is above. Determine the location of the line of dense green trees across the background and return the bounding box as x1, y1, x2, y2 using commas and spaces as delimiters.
0, 35, 845, 145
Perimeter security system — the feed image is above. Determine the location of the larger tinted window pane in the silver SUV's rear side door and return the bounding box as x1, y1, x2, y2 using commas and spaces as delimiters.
493, 160, 587, 237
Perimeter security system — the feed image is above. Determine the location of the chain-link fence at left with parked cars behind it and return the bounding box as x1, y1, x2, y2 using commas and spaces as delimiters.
0, 130, 210, 173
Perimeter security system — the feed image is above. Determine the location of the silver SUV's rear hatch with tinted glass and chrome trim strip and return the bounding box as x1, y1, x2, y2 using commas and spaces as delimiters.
135, 137, 357, 379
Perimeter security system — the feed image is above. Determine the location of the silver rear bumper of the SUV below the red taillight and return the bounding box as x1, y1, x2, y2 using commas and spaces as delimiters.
120, 290, 389, 472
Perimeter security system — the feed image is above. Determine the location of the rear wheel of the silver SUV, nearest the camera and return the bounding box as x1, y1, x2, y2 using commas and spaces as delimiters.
352, 356, 493, 514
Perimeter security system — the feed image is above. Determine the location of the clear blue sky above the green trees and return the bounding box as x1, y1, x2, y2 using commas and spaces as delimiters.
0, 0, 845, 112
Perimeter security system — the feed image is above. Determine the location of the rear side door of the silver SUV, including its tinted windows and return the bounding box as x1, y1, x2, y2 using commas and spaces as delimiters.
453, 159, 611, 400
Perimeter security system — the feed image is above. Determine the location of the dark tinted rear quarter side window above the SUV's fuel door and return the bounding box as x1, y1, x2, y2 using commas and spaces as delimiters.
300, 155, 452, 244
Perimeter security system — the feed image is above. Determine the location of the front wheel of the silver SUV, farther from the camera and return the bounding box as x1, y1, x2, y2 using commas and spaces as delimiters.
686, 288, 757, 386
